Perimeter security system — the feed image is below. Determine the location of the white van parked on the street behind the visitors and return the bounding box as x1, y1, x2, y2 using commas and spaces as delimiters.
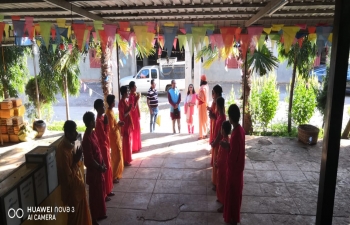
119, 61, 185, 93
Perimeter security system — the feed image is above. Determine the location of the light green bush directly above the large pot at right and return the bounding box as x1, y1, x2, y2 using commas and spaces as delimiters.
292, 76, 318, 125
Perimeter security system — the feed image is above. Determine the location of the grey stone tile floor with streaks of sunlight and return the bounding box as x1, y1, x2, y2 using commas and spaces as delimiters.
0, 131, 350, 225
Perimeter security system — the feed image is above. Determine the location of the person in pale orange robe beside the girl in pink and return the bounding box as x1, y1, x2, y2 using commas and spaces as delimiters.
197, 75, 209, 140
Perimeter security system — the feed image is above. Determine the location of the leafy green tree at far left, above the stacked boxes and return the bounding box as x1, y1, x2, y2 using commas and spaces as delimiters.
0, 46, 31, 98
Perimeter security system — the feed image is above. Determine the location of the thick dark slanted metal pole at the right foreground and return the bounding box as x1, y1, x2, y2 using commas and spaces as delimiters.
316, 0, 350, 225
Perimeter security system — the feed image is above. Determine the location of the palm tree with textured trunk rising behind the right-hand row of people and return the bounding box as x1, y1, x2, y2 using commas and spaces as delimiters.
196, 43, 278, 133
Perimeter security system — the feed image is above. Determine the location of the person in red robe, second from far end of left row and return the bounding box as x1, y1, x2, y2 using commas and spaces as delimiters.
118, 86, 134, 166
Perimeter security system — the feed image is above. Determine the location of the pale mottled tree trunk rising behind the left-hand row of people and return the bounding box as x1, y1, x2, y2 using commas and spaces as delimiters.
101, 46, 112, 105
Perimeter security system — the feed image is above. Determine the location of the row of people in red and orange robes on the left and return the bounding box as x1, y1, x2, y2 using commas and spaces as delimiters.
56, 82, 141, 225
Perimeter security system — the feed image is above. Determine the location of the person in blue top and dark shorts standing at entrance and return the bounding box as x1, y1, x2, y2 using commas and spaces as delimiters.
168, 80, 181, 134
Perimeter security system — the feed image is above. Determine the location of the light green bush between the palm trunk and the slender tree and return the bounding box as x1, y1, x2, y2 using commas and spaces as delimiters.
250, 75, 279, 132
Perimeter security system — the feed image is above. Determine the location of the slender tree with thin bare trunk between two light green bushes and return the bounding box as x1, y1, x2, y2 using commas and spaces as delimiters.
278, 36, 316, 133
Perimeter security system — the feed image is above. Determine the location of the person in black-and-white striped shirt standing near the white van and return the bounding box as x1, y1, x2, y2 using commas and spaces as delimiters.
147, 79, 159, 133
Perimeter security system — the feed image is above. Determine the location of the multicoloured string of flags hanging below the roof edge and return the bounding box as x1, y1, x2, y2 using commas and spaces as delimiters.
0, 15, 333, 56
